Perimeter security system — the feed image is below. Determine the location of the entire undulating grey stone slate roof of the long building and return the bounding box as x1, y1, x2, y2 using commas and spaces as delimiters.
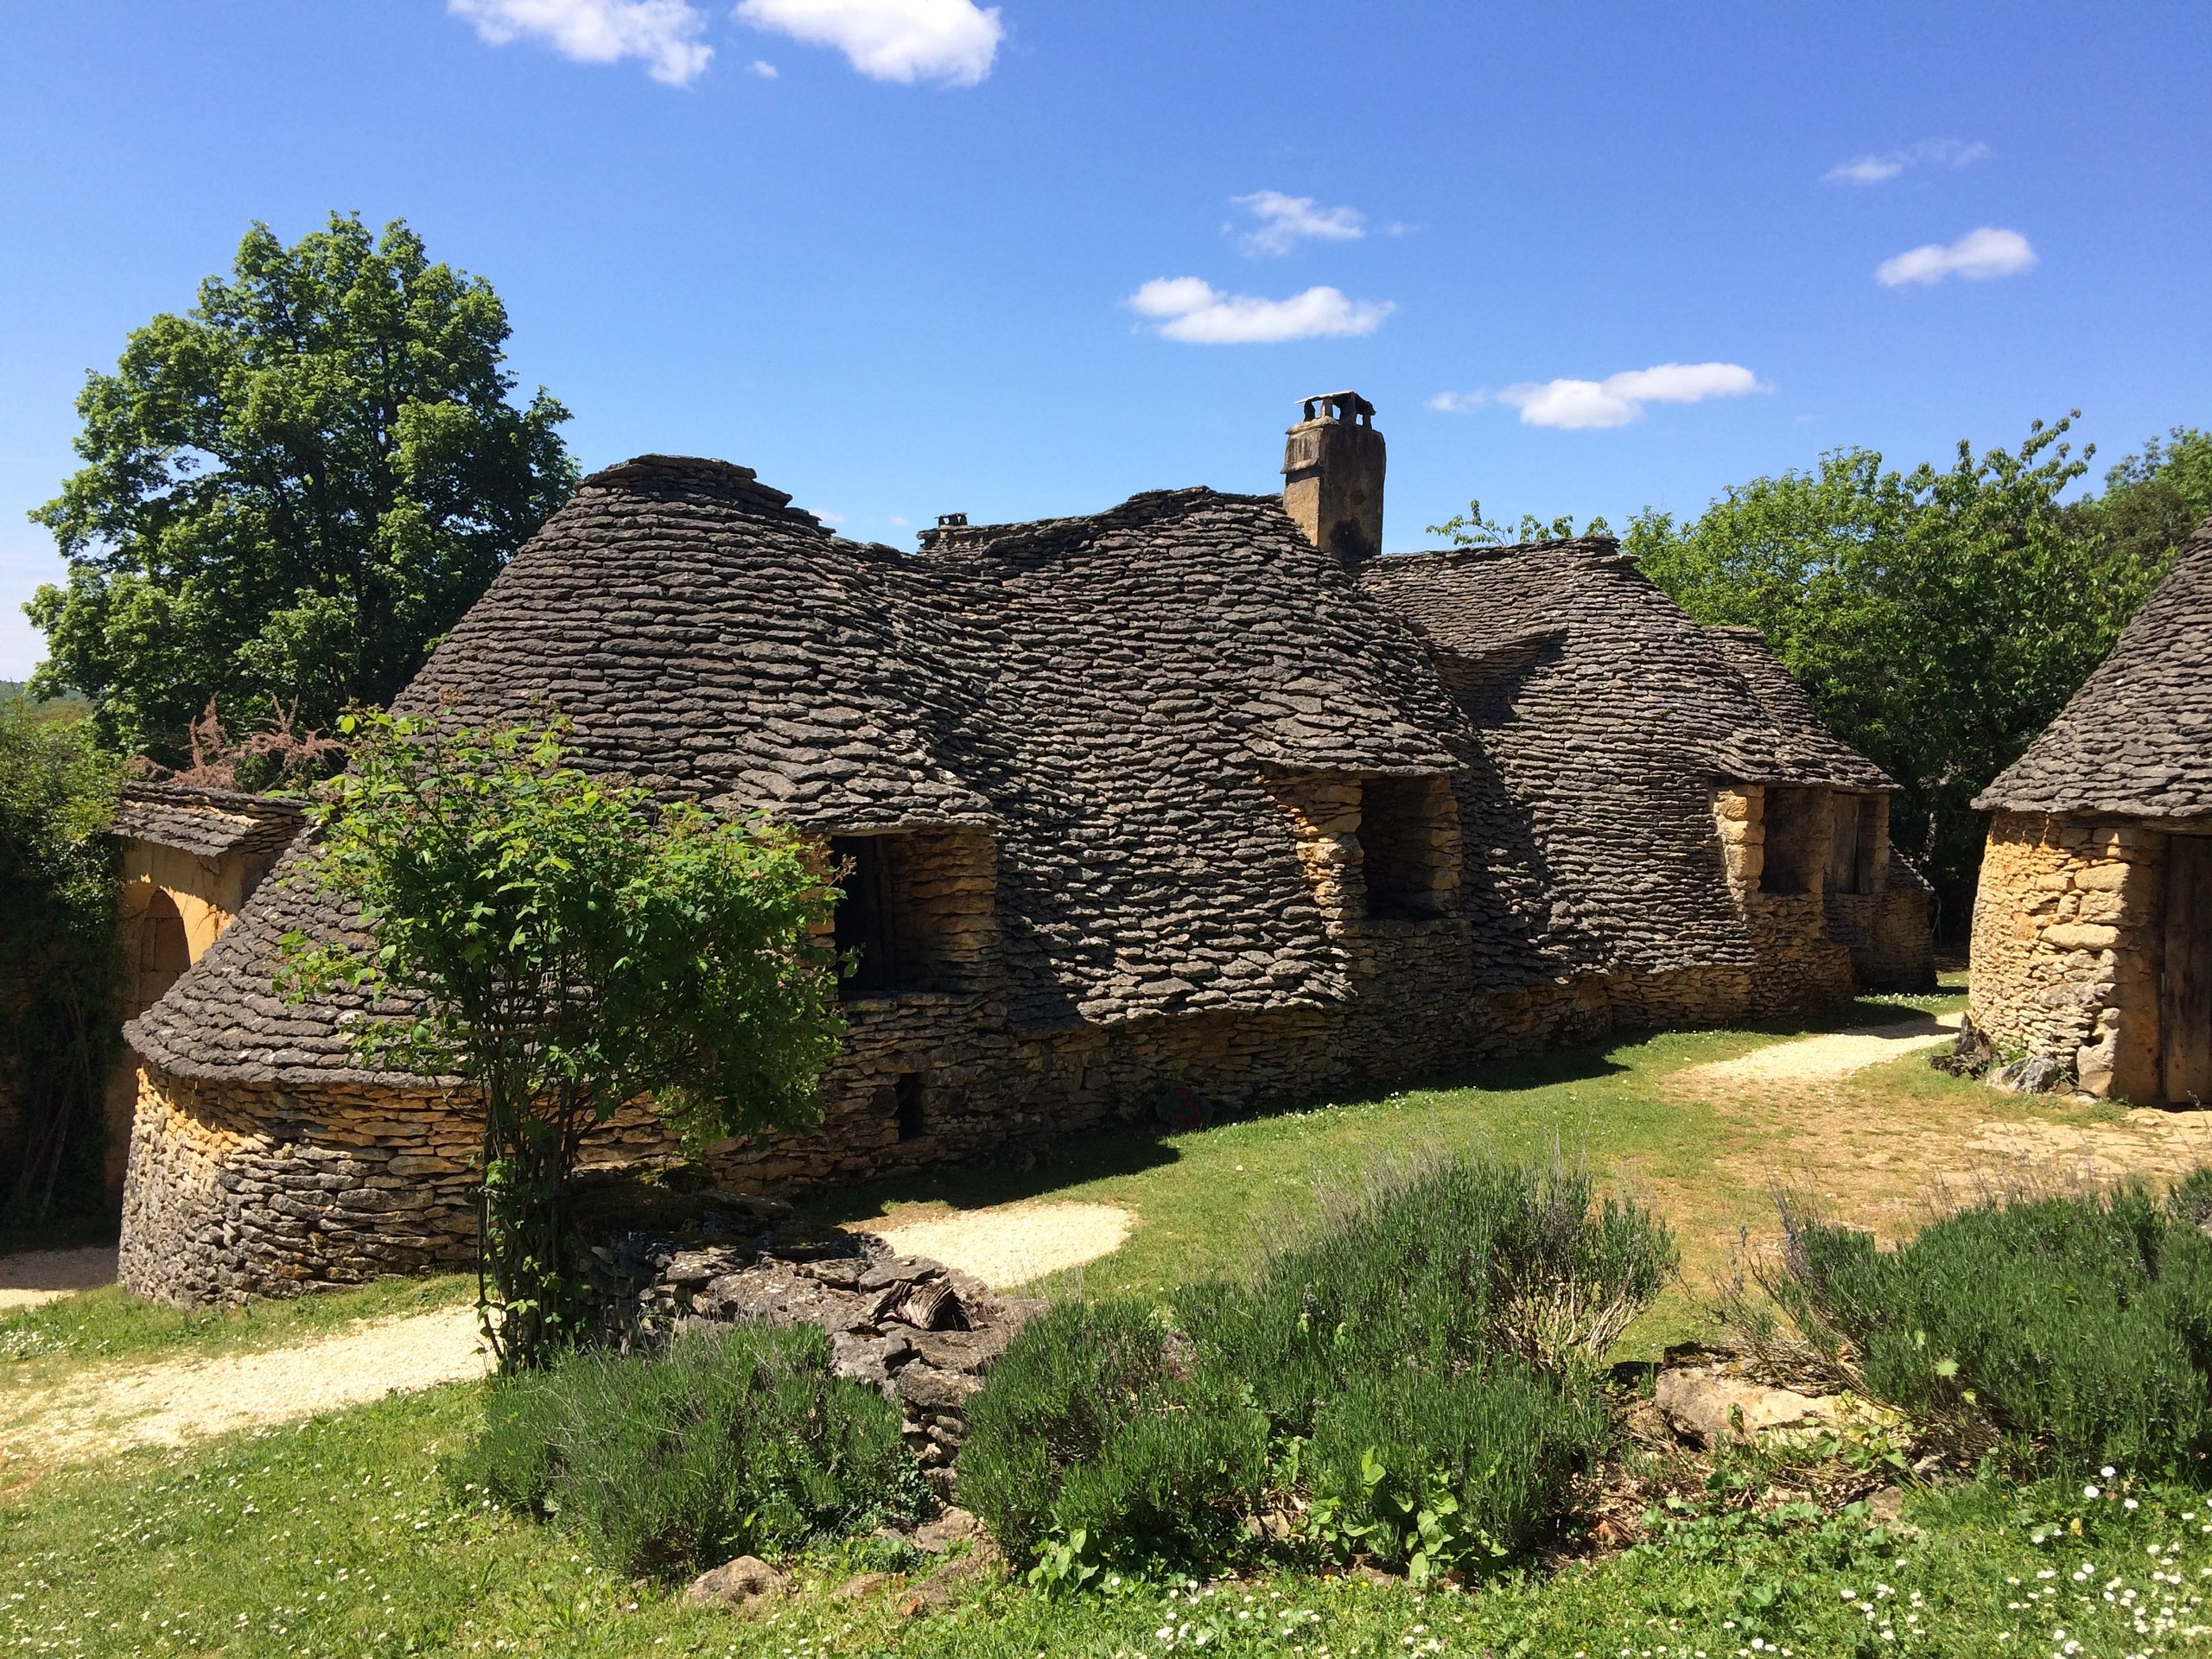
130, 455, 1902, 1082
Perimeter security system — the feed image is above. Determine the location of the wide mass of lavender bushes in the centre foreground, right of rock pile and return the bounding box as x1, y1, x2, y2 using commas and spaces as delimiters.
960, 1161, 1675, 1568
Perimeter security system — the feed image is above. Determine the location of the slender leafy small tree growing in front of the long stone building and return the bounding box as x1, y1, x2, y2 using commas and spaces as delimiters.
283, 712, 842, 1371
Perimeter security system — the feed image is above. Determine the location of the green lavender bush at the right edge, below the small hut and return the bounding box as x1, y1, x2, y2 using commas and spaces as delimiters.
1770, 1188, 2212, 1473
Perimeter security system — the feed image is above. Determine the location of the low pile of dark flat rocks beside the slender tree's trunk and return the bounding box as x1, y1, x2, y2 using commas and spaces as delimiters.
591, 1199, 1044, 1502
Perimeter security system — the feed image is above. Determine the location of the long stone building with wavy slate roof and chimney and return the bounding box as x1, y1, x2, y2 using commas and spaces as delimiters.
111, 394, 1931, 1299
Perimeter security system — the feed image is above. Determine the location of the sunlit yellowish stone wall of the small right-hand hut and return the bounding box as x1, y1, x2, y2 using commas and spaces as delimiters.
1968, 812, 2165, 1102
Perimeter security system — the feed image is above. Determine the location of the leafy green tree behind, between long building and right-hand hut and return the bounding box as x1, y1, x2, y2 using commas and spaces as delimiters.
1624, 416, 2172, 933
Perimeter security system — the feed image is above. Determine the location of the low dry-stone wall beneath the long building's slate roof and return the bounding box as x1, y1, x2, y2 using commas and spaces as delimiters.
119, 955, 1757, 1303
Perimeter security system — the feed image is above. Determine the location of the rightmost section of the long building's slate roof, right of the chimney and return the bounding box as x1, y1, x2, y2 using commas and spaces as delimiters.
1363, 536, 1891, 973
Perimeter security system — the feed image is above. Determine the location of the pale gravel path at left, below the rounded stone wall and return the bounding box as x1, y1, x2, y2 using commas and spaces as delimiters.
0, 1307, 489, 1478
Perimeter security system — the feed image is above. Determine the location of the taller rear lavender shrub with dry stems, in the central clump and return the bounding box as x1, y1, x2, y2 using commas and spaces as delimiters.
1181, 1159, 1676, 1433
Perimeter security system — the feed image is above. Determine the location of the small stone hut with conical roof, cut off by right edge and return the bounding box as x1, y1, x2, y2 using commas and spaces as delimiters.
1968, 520, 2212, 1103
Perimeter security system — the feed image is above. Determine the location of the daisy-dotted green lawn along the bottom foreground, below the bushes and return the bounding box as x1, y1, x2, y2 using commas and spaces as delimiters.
0, 1387, 2212, 1659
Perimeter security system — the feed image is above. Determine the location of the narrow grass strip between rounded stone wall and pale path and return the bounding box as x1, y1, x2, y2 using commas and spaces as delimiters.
0, 1274, 475, 1385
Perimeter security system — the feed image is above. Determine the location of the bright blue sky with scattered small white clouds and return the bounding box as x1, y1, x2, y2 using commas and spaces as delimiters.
0, 0, 2212, 677
